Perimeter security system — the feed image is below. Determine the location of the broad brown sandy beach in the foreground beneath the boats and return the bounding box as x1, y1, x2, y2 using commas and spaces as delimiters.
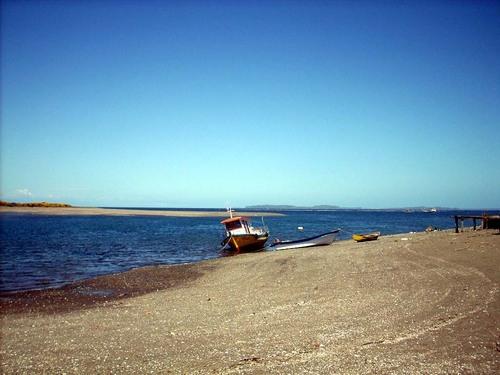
0, 230, 500, 374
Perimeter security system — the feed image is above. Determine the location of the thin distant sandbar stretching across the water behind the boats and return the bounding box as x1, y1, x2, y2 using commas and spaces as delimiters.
0, 207, 284, 217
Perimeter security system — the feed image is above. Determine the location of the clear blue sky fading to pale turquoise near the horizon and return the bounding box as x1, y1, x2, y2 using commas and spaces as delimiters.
1, 0, 500, 208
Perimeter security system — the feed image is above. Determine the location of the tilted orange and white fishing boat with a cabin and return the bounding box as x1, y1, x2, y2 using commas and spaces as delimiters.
221, 213, 269, 253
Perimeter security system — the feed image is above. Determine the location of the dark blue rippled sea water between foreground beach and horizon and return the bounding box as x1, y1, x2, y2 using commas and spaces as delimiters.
0, 211, 492, 292
